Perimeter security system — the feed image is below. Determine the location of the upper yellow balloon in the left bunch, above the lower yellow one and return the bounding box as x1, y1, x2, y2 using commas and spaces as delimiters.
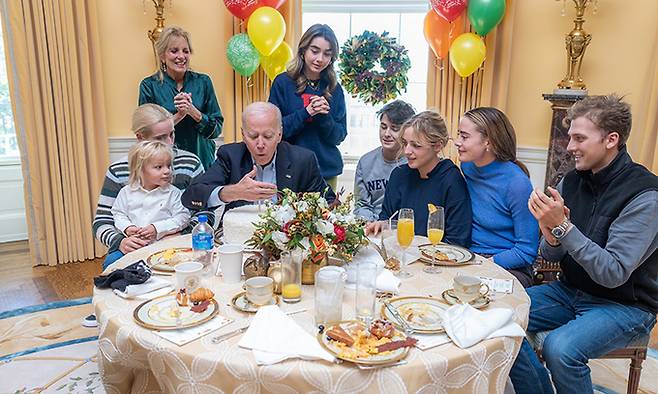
247, 7, 286, 56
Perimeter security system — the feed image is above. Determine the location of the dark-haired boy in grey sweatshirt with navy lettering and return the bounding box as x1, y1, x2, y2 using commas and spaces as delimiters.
354, 100, 416, 221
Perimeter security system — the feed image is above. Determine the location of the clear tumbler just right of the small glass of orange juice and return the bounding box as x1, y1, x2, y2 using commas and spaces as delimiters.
315, 266, 347, 325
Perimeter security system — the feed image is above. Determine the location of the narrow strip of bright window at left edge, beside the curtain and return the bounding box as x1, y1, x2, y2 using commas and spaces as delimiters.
0, 19, 19, 161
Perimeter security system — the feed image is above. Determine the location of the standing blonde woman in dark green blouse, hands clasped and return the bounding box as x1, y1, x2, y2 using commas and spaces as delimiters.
139, 26, 224, 169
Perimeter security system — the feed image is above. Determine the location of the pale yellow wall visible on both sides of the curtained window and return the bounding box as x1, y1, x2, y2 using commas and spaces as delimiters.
98, 0, 658, 159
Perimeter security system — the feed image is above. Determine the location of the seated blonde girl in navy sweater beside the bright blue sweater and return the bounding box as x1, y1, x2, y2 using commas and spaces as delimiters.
366, 111, 472, 247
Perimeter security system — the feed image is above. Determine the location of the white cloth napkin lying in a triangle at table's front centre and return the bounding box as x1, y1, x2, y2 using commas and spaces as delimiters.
238, 305, 334, 365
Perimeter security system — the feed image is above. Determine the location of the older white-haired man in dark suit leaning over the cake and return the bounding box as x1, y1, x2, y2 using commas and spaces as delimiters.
182, 102, 335, 211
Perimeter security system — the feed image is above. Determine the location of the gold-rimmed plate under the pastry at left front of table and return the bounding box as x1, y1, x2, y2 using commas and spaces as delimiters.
133, 295, 219, 330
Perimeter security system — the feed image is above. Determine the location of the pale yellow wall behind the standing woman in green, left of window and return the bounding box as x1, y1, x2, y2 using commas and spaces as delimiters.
97, 0, 233, 137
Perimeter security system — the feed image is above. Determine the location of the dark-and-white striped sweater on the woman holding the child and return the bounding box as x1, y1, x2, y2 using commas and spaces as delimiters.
92, 149, 209, 252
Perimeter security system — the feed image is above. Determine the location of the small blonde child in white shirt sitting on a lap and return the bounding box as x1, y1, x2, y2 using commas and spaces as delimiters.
104, 141, 190, 268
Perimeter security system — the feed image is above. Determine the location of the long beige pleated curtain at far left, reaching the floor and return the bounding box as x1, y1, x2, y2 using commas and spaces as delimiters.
0, 0, 108, 265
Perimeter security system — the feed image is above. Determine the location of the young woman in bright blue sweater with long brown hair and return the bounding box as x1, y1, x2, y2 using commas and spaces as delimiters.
455, 107, 539, 287
